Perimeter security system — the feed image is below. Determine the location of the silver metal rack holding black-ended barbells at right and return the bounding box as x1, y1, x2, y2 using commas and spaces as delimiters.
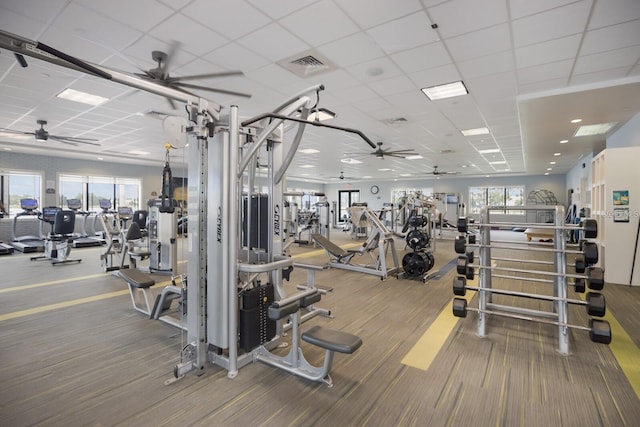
453, 206, 611, 355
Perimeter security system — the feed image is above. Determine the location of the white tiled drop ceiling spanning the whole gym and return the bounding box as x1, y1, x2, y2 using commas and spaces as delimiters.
0, 0, 640, 182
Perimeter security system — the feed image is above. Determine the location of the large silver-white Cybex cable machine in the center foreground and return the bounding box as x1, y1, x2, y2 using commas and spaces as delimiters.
0, 31, 376, 383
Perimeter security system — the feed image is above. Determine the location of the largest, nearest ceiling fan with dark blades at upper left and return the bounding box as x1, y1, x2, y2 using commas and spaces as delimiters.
134, 42, 251, 109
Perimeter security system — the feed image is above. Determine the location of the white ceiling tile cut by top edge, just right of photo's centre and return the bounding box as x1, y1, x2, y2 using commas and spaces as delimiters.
336, 0, 422, 29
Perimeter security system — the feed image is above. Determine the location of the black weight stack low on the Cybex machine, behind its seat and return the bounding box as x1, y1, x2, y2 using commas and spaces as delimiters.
239, 285, 276, 353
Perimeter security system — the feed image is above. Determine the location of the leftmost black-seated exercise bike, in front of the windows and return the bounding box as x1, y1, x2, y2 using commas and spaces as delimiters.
31, 207, 82, 265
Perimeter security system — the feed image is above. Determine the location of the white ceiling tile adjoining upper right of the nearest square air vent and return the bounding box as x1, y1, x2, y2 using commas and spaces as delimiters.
318, 33, 384, 67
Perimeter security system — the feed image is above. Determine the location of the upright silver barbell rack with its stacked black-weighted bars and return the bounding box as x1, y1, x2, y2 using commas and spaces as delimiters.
453, 206, 611, 355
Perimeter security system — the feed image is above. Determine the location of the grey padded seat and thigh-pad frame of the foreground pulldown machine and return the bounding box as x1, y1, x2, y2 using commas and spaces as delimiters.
256, 289, 362, 387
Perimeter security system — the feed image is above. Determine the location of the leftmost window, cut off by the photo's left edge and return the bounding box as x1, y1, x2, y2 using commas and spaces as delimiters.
0, 171, 42, 215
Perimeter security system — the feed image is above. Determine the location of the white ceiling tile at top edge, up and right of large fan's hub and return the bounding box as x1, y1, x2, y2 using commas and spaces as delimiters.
181, 0, 271, 39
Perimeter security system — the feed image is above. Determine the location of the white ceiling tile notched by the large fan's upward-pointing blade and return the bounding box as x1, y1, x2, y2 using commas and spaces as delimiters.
149, 13, 228, 55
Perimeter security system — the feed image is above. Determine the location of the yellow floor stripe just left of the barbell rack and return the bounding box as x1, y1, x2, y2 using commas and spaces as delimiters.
402, 279, 476, 371
